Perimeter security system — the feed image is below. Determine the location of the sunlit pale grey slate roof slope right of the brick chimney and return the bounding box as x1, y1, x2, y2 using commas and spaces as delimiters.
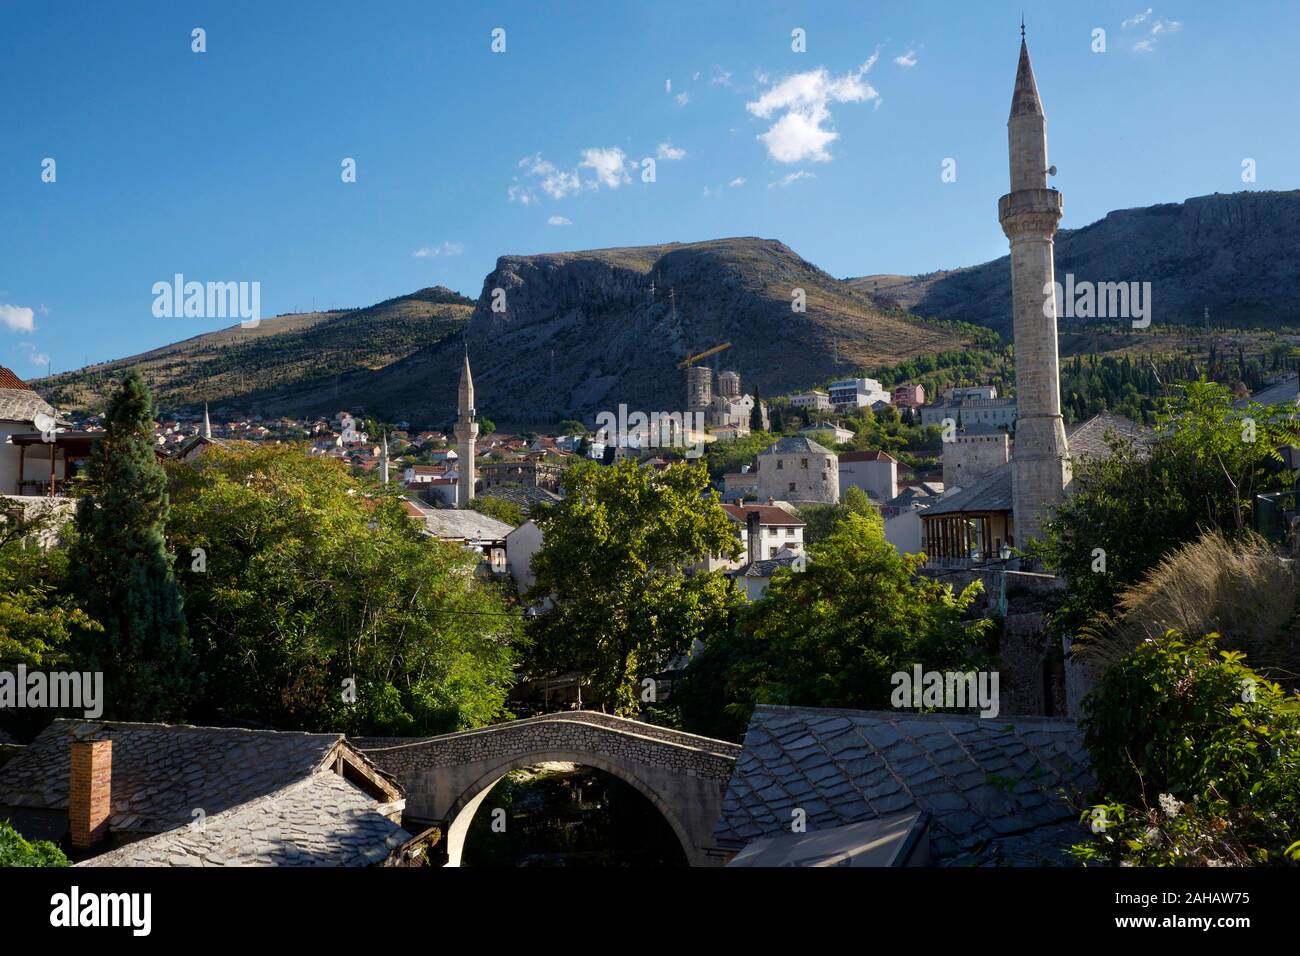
78, 770, 411, 866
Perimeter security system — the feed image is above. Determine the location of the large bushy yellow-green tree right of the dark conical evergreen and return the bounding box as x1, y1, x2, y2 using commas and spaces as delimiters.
169, 446, 520, 734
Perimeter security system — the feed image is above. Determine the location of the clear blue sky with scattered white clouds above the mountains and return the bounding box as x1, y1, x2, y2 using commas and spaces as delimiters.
0, 0, 1300, 377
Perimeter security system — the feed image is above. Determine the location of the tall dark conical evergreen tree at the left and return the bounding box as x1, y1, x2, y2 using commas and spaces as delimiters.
69, 371, 199, 721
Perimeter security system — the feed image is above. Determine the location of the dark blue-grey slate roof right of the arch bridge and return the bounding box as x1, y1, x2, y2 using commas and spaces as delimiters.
714, 705, 1092, 865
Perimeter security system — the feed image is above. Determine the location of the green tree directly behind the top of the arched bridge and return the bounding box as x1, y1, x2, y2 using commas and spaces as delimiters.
527, 462, 744, 714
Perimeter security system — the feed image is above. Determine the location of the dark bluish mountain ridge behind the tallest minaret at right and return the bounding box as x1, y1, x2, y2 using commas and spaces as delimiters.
852, 191, 1300, 334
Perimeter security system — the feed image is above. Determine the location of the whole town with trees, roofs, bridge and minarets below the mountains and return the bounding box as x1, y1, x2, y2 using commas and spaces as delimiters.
0, 18, 1300, 925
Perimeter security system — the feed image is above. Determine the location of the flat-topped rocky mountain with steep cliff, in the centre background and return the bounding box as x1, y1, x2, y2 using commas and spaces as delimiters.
236, 238, 971, 427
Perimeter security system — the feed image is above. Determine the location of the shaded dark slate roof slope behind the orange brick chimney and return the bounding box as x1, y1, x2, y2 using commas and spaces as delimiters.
0, 719, 343, 834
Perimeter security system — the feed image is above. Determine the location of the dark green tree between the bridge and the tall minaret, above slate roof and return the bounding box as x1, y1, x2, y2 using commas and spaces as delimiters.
673, 512, 991, 739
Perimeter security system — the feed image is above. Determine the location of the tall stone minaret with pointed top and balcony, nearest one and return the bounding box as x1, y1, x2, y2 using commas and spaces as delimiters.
997, 23, 1070, 548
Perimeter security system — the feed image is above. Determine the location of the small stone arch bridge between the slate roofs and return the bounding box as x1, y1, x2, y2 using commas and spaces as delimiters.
351, 710, 741, 866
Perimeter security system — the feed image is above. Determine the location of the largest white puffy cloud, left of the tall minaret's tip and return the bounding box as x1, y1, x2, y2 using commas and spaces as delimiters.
745, 53, 880, 163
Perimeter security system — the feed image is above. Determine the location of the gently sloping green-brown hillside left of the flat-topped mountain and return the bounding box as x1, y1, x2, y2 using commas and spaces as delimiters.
35, 286, 473, 411
